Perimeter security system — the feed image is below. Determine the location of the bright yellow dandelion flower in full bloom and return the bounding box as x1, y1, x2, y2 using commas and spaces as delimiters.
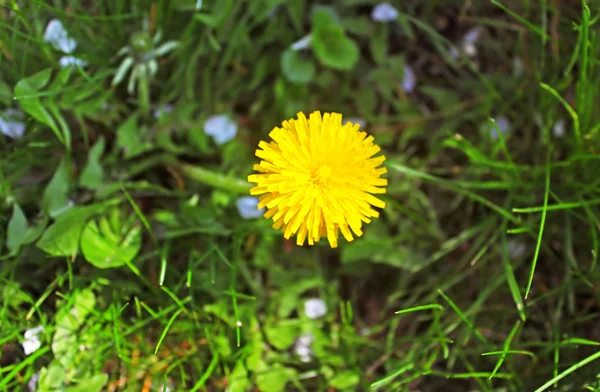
248, 111, 387, 248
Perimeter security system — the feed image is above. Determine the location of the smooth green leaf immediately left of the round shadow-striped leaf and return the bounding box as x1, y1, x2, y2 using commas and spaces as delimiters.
36, 207, 96, 257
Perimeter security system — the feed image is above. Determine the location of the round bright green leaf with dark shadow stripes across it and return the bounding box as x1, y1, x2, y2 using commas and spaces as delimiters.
81, 211, 142, 268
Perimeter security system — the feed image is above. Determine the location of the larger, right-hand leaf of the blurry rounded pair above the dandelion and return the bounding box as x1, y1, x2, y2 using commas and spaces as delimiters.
312, 25, 359, 70
